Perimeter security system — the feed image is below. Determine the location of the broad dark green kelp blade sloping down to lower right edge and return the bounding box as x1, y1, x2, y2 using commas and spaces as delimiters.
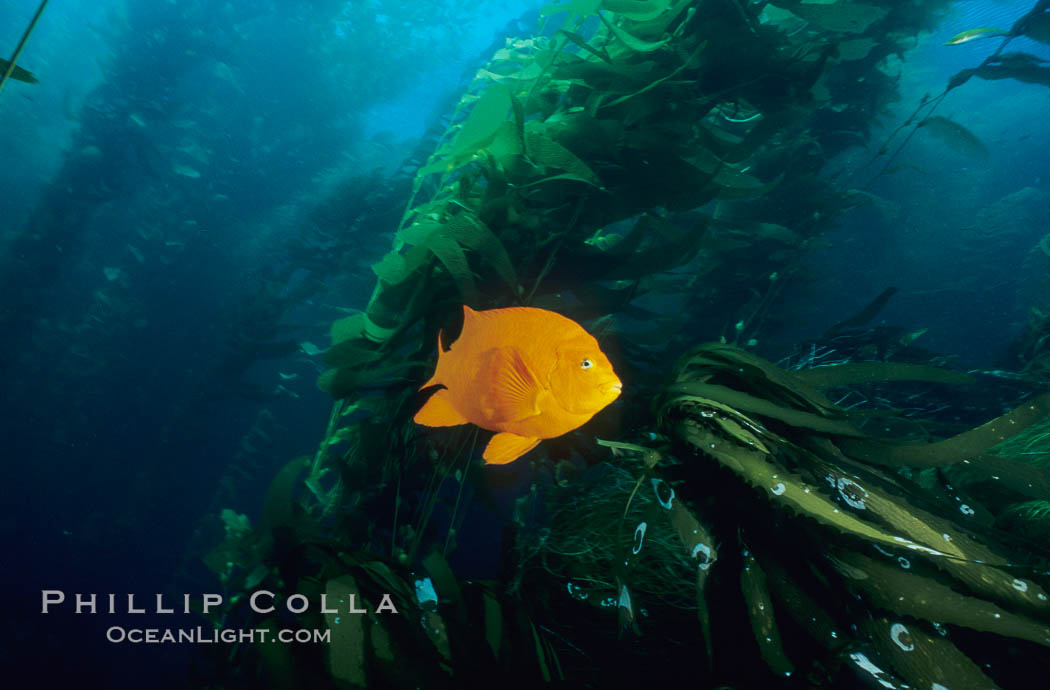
828, 550, 1050, 646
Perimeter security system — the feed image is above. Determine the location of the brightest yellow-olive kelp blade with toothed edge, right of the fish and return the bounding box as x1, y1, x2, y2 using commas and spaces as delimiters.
674, 419, 945, 556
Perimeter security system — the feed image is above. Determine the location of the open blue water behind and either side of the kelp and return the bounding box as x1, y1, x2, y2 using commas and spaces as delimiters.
0, 0, 1050, 687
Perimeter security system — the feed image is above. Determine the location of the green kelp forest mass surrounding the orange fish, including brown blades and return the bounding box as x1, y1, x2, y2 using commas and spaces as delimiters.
200, 0, 1050, 690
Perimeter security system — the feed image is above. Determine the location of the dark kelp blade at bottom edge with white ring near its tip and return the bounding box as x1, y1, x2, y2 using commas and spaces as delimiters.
862, 618, 999, 690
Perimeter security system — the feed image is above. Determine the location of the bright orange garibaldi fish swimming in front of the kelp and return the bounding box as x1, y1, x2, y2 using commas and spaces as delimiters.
415, 305, 623, 464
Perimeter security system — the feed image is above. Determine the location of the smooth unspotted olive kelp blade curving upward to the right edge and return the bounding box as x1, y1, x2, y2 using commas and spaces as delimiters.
838, 393, 1050, 467
